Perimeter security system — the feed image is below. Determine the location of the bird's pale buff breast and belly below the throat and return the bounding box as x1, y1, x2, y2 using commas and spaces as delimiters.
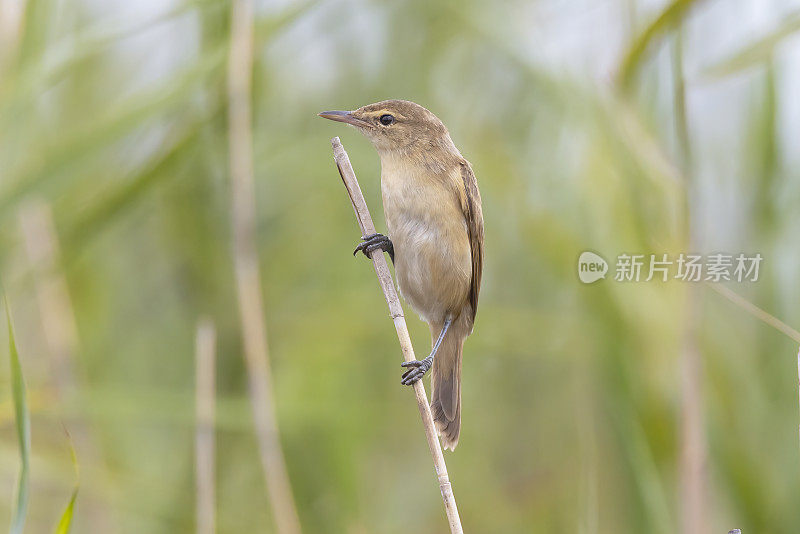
381, 163, 472, 322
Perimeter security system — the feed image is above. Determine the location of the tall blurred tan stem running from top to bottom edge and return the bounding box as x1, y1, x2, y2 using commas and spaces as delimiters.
228, 0, 300, 534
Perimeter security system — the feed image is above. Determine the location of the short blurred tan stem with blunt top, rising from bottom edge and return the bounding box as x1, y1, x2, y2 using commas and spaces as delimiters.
195, 319, 217, 534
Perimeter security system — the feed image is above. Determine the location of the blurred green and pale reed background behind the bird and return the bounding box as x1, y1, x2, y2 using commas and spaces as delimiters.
0, 0, 800, 534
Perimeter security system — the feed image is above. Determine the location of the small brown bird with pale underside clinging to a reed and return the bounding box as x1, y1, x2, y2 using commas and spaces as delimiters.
319, 100, 483, 450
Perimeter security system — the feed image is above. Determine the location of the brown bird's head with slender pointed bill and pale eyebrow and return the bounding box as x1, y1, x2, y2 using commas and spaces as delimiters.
319, 100, 452, 152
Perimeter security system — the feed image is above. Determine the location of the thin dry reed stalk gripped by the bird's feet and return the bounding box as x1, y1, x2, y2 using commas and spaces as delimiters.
331, 137, 463, 534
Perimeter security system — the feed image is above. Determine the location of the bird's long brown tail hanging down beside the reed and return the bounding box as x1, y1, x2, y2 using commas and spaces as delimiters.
431, 324, 466, 451
